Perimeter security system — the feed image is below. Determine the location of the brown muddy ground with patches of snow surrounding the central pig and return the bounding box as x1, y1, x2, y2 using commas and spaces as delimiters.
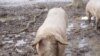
0, 3, 100, 56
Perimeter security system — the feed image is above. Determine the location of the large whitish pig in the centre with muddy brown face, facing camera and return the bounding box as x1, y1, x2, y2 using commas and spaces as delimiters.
32, 7, 68, 56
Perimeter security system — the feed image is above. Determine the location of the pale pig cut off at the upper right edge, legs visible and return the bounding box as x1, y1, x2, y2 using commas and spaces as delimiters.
86, 0, 100, 30
